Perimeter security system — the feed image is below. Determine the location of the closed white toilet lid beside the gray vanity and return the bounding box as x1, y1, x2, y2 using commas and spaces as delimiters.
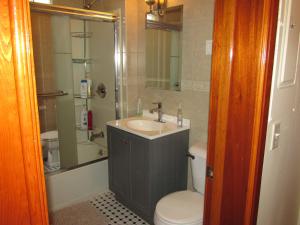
156, 191, 204, 224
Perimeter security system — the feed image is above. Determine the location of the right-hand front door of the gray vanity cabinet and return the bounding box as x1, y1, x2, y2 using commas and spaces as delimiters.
130, 135, 150, 214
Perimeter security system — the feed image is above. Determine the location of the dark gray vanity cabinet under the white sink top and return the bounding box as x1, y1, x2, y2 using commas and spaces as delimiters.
107, 126, 189, 224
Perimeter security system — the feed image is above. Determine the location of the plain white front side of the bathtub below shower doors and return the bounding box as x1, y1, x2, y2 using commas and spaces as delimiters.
46, 160, 108, 211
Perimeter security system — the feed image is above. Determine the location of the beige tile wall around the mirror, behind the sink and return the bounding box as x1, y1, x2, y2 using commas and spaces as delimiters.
126, 0, 214, 144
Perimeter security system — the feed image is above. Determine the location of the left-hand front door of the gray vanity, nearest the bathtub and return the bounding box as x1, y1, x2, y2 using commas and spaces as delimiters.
108, 128, 130, 199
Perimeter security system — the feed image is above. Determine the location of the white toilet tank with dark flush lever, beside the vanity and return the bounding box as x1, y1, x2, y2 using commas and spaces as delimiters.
189, 143, 207, 194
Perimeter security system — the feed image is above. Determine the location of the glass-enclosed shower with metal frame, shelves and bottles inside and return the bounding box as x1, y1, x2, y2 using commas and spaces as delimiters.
31, 0, 121, 173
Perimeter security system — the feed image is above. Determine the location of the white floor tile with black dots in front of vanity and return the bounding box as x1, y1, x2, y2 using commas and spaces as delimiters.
90, 192, 149, 225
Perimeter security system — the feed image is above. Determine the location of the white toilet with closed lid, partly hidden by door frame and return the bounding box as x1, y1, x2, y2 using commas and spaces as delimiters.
154, 144, 207, 225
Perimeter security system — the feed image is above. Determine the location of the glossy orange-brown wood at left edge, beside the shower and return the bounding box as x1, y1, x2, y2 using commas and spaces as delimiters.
0, 0, 48, 225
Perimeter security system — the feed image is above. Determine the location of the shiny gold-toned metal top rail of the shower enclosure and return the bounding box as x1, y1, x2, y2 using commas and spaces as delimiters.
30, 2, 118, 22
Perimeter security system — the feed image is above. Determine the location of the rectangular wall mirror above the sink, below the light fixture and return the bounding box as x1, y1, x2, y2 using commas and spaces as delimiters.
145, 5, 183, 91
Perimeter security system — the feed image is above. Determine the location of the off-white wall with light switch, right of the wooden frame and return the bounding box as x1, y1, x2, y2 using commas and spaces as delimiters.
257, 0, 300, 225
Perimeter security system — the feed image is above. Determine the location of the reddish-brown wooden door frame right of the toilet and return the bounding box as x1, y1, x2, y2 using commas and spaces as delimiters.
204, 0, 279, 225
